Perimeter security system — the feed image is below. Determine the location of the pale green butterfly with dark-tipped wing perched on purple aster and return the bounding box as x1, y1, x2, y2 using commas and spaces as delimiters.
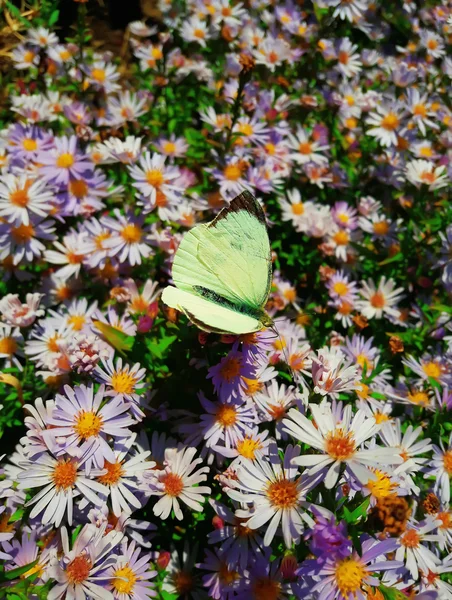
162, 191, 273, 335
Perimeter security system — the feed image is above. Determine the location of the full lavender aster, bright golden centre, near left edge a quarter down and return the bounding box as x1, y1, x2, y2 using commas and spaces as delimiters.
37, 135, 94, 185
